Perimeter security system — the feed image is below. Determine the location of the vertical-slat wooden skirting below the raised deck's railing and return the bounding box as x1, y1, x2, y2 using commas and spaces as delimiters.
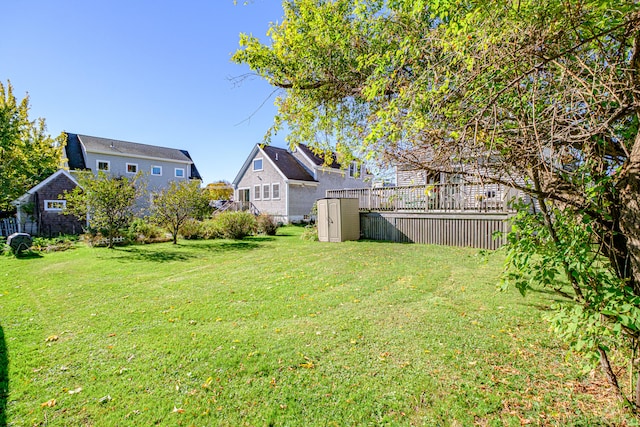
360, 212, 510, 249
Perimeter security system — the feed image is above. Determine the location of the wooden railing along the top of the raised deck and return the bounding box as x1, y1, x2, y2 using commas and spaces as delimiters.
326, 184, 522, 212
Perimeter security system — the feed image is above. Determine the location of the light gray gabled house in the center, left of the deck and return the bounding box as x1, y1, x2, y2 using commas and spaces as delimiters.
233, 144, 371, 223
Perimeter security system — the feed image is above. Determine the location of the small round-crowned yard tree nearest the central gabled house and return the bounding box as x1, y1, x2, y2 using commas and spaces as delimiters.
151, 181, 209, 244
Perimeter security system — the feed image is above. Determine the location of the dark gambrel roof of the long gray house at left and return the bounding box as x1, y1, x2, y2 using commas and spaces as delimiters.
65, 132, 201, 179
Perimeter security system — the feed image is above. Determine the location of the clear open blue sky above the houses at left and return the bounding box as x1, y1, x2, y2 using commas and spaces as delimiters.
0, 0, 284, 184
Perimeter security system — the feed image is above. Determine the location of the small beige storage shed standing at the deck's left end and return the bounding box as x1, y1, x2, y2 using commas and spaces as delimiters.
317, 199, 360, 242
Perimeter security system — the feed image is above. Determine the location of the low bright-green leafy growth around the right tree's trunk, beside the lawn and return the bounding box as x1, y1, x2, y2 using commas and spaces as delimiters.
503, 205, 640, 376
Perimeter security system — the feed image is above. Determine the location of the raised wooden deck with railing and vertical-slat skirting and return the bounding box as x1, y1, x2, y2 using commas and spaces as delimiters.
326, 184, 522, 249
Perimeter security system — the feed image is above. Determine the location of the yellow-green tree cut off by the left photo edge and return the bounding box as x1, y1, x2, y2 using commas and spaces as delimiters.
0, 82, 65, 211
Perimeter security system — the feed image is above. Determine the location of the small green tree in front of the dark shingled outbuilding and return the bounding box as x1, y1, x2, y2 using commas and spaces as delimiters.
64, 172, 144, 248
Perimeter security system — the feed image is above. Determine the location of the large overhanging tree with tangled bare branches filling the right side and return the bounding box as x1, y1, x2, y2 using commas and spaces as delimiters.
234, 0, 640, 408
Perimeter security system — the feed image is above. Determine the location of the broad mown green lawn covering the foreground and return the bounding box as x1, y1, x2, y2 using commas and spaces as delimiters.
0, 227, 628, 427
